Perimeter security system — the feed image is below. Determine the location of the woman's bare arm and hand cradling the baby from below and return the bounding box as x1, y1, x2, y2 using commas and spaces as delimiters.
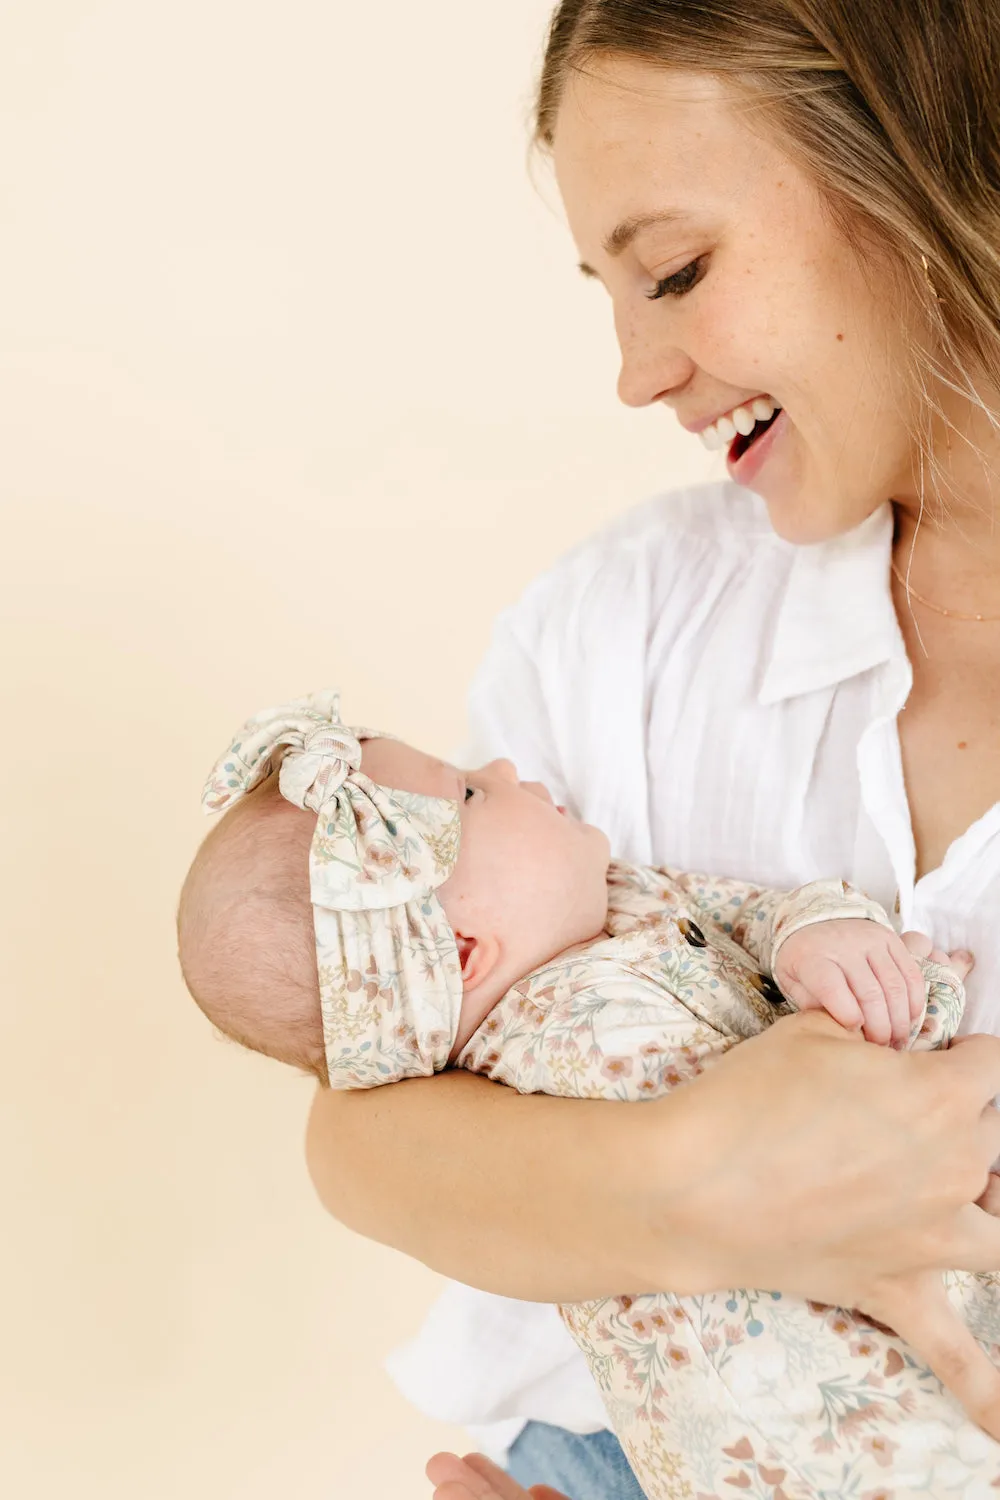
307, 1013, 1000, 1316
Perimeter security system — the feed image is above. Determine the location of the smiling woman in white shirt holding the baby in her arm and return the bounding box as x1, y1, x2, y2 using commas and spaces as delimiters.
309, 0, 1000, 1500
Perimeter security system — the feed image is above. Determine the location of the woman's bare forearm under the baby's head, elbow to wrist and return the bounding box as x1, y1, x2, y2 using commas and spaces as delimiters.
307, 1070, 670, 1302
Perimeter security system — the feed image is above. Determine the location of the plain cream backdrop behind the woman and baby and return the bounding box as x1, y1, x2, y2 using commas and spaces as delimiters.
0, 0, 711, 1500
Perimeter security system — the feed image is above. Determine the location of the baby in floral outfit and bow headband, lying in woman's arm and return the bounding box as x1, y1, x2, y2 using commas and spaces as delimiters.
178, 695, 1000, 1500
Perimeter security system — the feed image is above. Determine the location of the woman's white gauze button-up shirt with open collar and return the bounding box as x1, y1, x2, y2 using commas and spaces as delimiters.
388, 483, 1000, 1460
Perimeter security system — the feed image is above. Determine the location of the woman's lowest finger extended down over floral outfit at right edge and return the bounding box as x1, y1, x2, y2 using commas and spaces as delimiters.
864, 1272, 1000, 1440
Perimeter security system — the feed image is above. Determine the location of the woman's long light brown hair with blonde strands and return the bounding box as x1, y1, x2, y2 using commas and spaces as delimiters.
535, 0, 1000, 504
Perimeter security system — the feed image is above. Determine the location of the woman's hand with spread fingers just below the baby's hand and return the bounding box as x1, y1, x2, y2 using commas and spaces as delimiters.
673, 1011, 1000, 1439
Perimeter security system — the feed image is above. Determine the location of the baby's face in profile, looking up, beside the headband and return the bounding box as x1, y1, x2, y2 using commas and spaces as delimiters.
361, 740, 610, 974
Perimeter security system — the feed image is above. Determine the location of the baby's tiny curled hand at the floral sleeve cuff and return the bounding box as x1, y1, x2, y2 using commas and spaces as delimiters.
774, 917, 972, 1047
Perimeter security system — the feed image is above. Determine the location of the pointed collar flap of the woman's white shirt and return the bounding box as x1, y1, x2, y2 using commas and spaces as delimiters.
759, 504, 906, 704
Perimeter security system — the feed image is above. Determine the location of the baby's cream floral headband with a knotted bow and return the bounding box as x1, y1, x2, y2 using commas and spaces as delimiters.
201, 693, 462, 1089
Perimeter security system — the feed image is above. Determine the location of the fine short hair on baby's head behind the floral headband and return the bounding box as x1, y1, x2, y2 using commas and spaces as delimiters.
177, 782, 328, 1085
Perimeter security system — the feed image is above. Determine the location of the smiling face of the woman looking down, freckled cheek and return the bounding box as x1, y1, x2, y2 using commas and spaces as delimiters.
555, 60, 916, 543
